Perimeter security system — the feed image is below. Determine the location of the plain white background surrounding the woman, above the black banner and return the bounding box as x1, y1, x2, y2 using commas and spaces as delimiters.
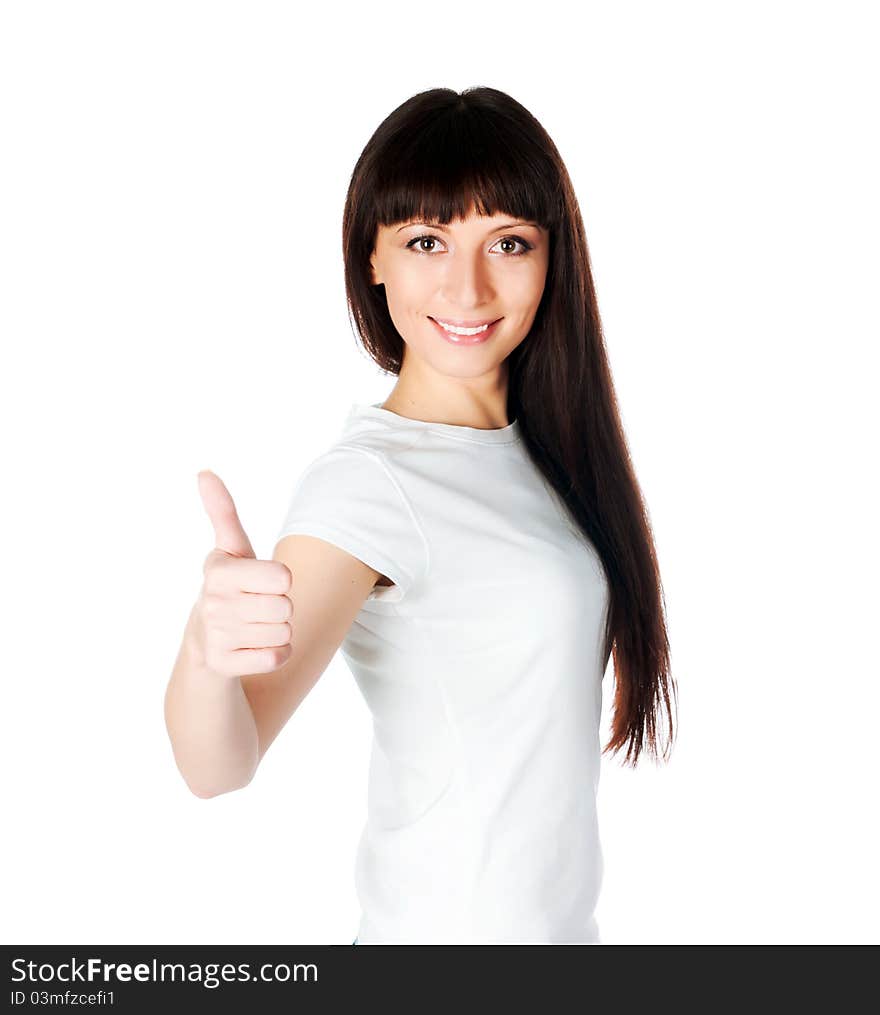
0, 0, 880, 944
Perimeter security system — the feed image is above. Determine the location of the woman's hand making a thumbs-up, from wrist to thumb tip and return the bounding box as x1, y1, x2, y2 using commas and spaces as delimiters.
193, 470, 293, 678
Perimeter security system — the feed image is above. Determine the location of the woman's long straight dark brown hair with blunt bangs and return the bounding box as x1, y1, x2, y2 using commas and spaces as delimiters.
342, 87, 678, 767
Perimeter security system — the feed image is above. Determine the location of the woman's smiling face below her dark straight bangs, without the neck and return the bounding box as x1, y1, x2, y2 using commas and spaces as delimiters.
370, 209, 549, 379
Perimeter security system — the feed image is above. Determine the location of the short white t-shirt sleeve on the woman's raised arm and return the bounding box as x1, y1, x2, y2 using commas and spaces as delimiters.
276, 447, 427, 599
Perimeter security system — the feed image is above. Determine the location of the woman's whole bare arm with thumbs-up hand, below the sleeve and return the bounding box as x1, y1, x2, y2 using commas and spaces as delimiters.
164, 473, 381, 798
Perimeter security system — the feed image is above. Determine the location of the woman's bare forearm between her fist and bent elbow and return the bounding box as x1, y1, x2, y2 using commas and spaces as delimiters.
164, 614, 260, 797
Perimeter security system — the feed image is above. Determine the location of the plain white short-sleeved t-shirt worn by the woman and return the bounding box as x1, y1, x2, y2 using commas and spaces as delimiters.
278, 404, 608, 945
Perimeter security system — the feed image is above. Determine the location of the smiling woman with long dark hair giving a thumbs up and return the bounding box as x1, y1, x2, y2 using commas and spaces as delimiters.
165, 87, 675, 944
